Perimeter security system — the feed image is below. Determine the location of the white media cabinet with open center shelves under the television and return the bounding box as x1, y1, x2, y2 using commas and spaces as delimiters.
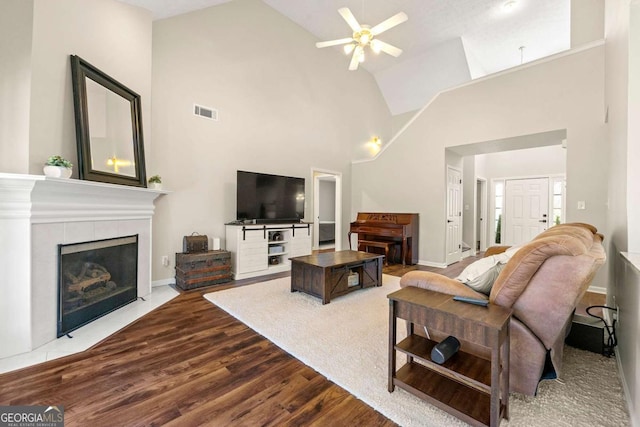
226, 223, 312, 280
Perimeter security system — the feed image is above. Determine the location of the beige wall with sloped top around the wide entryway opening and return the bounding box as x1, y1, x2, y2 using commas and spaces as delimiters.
352, 45, 608, 270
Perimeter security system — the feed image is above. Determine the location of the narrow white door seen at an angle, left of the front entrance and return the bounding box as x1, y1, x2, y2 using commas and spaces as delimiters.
445, 166, 462, 265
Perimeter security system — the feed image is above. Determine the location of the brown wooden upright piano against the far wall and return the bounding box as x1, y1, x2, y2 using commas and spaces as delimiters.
348, 212, 419, 265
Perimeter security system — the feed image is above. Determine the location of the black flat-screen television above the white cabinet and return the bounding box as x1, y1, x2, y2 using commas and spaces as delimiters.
236, 171, 304, 224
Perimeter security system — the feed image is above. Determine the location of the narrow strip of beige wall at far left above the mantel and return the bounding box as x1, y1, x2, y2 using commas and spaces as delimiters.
0, 0, 33, 173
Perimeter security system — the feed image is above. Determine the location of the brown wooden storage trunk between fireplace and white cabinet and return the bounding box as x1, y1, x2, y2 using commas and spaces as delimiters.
176, 251, 233, 290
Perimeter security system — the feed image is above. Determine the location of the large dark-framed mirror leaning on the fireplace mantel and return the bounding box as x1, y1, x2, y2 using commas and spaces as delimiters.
71, 55, 147, 187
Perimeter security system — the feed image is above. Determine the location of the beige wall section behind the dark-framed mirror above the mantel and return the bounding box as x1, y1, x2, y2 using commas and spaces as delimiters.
28, 0, 151, 178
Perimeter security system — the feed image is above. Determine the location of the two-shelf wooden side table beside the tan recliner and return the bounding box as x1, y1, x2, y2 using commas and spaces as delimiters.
388, 286, 511, 426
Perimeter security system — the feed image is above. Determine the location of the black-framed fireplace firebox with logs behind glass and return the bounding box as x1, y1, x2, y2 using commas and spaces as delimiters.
57, 235, 138, 337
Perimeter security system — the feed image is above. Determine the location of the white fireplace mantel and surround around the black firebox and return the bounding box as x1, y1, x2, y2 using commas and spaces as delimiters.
0, 173, 166, 358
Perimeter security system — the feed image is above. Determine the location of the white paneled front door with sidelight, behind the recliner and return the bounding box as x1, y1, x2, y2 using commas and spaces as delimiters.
502, 178, 549, 245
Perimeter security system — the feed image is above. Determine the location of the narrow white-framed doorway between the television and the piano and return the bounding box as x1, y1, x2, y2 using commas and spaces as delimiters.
311, 169, 342, 250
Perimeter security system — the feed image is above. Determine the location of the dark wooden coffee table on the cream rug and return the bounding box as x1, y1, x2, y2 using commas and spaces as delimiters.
289, 251, 384, 304
